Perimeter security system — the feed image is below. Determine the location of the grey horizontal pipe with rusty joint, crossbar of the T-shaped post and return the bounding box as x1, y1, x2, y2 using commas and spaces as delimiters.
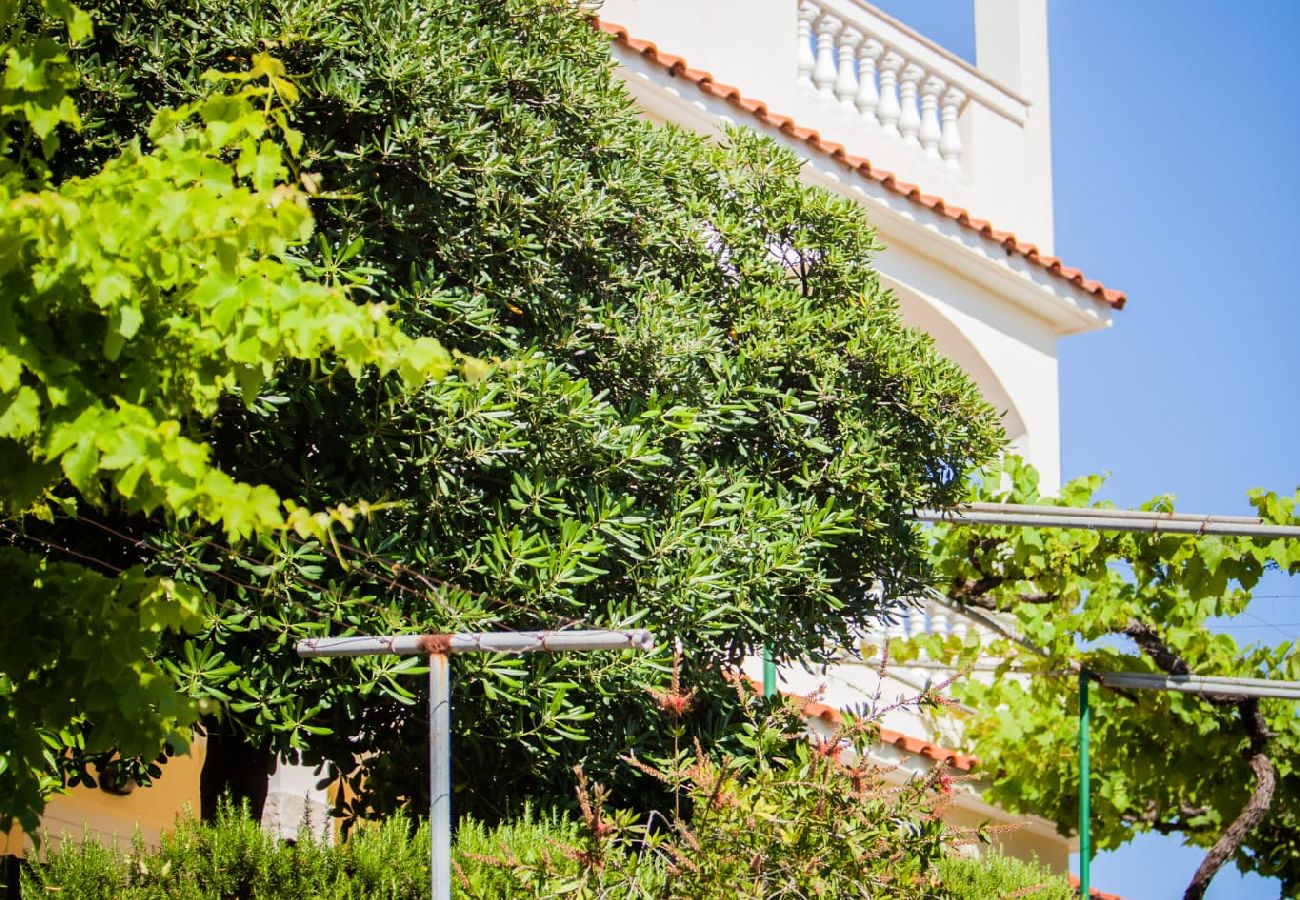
296, 628, 654, 657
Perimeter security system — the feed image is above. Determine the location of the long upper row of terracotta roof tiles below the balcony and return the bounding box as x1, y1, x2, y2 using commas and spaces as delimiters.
592, 18, 1128, 310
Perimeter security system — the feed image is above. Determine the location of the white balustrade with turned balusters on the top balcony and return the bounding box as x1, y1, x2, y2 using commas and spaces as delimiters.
797, 0, 1008, 172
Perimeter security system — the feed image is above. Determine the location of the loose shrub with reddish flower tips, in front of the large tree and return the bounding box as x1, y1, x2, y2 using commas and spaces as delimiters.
452, 691, 967, 900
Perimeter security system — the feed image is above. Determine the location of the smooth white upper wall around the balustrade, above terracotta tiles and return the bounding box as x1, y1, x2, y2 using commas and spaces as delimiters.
599, 0, 1053, 251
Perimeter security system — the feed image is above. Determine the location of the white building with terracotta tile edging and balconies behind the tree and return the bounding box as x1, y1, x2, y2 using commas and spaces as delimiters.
598, 0, 1125, 871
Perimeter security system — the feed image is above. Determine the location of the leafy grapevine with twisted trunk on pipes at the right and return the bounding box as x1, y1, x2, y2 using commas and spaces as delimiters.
923, 459, 1300, 897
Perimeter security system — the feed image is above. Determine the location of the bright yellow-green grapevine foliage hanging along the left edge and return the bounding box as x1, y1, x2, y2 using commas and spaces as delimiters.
0, 0, 450, 830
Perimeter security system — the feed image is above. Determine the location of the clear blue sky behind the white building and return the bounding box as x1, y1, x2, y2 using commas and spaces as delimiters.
876, 0, 1300, 900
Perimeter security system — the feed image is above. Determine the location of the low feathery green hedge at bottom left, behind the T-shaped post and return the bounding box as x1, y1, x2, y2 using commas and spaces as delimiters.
22, 804, 624, 900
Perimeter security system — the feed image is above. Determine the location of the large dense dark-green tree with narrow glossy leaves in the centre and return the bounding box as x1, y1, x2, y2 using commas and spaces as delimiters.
12, 0, 1001, 817
